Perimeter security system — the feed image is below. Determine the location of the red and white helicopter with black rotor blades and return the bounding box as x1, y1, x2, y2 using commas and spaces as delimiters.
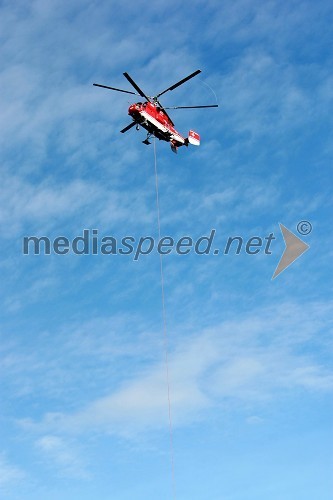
93, 69, 218, 153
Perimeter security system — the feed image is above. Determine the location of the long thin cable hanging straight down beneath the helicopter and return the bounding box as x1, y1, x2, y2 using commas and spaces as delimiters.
154, 137, 176, 499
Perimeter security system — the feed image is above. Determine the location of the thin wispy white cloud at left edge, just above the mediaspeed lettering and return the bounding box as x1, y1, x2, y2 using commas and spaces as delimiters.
0, 166, 154, 239
